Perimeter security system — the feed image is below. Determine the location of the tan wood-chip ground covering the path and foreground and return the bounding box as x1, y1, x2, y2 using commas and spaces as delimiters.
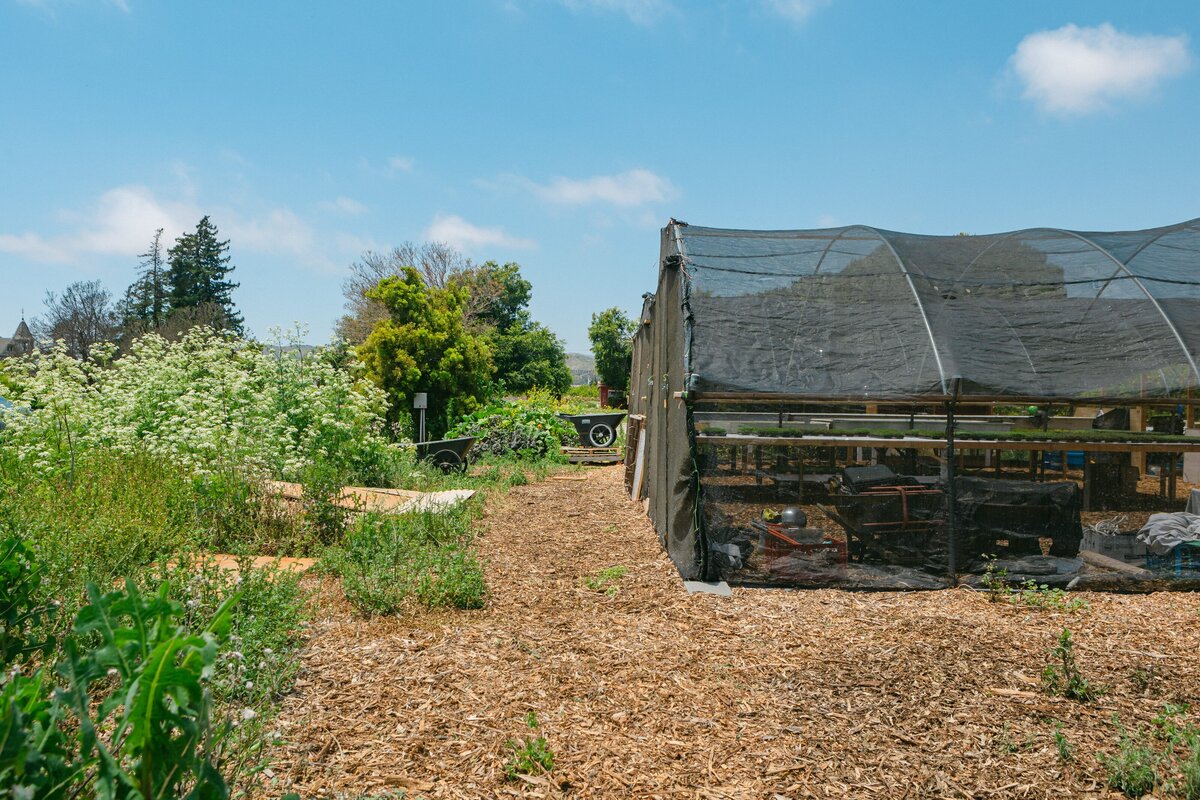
274, 467, 1200, 798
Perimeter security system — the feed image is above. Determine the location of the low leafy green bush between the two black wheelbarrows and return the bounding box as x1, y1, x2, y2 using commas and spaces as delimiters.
446, 392, 576, 459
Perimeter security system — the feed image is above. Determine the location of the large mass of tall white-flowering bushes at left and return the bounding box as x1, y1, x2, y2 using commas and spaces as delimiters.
0, 327, 400, 480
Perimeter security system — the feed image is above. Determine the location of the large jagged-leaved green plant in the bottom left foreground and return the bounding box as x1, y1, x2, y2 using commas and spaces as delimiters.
0, 581, 236, 800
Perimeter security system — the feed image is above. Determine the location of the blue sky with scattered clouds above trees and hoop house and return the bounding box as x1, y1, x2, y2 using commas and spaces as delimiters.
0, 0, 1200, 351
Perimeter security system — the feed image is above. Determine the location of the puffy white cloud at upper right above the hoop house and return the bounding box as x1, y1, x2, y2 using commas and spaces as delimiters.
1009, 23, 1192, 115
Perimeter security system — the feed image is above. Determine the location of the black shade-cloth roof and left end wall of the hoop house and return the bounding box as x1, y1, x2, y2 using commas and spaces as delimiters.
630, 219, 1200, 585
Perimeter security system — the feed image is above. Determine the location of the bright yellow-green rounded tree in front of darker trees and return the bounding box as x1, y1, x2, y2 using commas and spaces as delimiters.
358, 266, 492, 438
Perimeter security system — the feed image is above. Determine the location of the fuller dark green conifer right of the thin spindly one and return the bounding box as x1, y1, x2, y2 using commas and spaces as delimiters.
167, 216, 244, 333
